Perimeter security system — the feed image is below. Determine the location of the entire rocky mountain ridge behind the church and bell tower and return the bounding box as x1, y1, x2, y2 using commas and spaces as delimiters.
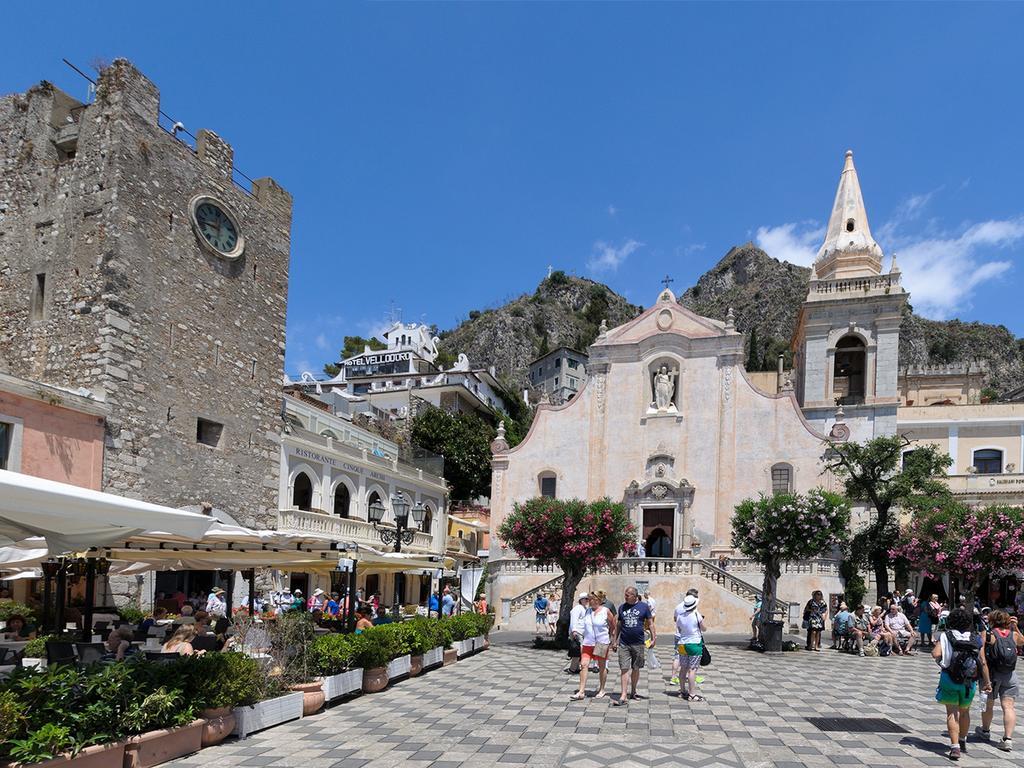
441, 243, 1024, 391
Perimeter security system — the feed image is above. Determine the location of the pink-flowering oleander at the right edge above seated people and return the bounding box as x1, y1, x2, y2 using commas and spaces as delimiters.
890, 498, 1024, 605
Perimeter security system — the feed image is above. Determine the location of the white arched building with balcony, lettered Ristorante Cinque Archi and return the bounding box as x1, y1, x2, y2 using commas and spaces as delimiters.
278, 392, 447, 605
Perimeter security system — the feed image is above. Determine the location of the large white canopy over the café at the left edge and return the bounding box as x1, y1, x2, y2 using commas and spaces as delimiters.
0, 470, 213, 552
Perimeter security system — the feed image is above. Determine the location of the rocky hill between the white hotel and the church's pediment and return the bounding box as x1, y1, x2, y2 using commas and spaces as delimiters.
438, 271, 641, 390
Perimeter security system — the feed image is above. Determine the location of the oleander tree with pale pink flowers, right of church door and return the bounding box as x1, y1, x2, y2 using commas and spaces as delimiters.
732, 488, 850, 624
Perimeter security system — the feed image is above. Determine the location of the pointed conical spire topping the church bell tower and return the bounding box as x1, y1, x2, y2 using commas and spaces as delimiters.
814, 150, 882, 280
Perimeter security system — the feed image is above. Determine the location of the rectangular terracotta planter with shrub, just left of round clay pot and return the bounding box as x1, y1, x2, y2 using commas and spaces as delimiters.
123, 686, 206, 768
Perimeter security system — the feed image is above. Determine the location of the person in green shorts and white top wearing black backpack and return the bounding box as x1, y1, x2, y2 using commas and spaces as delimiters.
932, 608, 992, 760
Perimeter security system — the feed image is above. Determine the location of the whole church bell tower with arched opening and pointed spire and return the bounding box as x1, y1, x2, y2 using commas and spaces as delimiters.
793, 152, 907, 440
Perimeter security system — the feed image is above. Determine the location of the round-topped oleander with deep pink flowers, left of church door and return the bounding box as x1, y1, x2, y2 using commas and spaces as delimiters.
498, 497, 637, 642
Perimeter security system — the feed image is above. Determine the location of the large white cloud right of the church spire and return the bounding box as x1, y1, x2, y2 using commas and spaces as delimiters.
890, 216, 1024, 319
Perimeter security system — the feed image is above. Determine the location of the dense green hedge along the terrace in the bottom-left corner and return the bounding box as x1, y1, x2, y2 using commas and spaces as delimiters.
0, 652, 268, 763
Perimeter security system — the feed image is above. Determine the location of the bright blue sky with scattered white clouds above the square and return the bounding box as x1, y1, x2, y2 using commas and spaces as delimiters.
0, 2, 1024, 374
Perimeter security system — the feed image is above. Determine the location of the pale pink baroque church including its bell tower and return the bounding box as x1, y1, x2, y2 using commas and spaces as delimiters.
490, 152, 1024, 631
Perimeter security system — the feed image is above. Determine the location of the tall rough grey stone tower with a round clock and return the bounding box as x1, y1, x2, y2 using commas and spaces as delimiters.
0, 60, 292, 527
